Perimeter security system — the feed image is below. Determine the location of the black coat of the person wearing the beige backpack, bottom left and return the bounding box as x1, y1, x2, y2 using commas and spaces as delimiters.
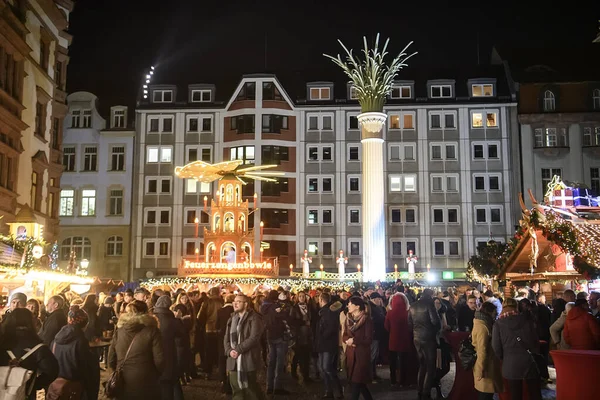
0, 329, 58, 400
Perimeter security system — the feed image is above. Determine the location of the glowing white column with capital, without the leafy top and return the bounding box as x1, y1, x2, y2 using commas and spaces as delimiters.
358, 112, 387, 282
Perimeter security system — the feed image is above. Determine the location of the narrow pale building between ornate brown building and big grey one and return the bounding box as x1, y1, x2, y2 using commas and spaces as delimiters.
59, 92, 135, 279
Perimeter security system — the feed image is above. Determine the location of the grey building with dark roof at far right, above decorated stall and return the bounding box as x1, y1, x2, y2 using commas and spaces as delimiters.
519, 81, 600, 201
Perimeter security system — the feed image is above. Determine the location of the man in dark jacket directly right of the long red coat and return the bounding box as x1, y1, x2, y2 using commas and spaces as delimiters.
408, 289, 441, 399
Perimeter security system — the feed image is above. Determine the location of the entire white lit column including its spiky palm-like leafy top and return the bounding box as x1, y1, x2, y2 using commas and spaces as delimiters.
324, 34, 414, 281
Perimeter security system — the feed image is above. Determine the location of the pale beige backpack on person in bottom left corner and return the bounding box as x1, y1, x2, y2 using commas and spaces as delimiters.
0, 343, 44, 400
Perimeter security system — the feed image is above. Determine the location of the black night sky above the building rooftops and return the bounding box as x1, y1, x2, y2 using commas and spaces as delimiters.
67, 0, 600, 113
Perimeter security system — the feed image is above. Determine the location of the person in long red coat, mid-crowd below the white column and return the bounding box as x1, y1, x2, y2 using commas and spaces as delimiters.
385, 292, 413, 386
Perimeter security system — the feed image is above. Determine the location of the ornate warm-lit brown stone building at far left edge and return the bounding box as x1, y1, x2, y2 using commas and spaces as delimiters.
0, 0, 73, 242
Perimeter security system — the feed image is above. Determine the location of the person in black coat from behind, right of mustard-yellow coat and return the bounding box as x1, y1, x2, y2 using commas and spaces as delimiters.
492, 298, 542, 400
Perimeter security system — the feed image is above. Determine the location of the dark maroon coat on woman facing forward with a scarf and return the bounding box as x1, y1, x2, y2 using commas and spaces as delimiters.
343, 315, 373, 384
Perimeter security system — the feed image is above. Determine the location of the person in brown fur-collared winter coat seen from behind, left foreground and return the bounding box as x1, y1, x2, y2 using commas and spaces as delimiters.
108, 300, 164, 400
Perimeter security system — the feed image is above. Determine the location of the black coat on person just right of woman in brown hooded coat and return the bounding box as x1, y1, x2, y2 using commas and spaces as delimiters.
154, 307, 188, 381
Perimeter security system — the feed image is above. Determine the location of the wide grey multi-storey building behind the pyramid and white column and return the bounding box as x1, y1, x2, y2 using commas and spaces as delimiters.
132, 67, 520, 278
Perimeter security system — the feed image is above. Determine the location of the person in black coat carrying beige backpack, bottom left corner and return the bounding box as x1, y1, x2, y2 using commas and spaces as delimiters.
0, 308, 58, 400
